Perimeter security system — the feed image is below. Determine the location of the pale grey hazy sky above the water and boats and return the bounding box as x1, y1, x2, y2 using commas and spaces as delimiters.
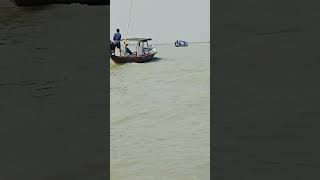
110, 0, 210, 43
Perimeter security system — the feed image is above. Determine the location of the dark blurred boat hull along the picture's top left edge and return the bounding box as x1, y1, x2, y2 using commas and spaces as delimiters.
11, 0, 110, 6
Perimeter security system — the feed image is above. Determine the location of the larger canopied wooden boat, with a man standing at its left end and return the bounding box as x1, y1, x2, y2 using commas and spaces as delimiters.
110, 38, 157, 64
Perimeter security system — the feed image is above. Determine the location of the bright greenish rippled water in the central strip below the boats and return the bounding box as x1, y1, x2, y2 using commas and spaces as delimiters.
110, 44, 210, 180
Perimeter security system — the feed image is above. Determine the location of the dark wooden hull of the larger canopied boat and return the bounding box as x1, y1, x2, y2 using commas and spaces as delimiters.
111, 52, 156, 64
